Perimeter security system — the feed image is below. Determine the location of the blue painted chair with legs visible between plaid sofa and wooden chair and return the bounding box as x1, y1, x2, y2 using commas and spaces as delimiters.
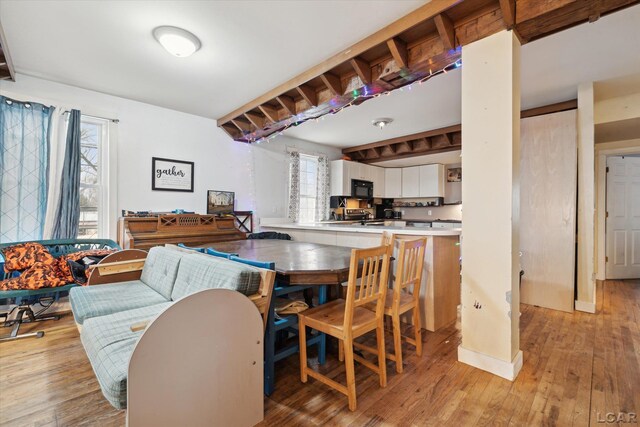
230, 256, 327, 396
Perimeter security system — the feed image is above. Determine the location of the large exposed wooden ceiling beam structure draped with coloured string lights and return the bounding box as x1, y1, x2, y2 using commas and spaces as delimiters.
218, 0, 639, 144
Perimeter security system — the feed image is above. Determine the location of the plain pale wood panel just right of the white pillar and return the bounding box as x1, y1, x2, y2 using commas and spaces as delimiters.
520, 110, 578, 312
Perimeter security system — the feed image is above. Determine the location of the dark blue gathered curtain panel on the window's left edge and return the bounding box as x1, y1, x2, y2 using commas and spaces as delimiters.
51, 110, 81, 239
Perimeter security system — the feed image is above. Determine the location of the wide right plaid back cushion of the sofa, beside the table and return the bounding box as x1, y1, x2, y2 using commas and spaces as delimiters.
171, 253, 260, 301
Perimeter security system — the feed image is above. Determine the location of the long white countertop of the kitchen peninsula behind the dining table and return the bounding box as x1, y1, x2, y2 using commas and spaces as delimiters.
260, 222, 462, 236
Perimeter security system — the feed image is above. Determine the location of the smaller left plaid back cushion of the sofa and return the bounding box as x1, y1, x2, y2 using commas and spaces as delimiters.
140, 246, 185, 300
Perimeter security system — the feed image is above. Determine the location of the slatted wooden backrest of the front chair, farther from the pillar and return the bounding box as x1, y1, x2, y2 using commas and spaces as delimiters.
344, 245, 391, 330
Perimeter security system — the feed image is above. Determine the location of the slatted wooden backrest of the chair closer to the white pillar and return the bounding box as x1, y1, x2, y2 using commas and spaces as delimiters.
393, 237, 427, 305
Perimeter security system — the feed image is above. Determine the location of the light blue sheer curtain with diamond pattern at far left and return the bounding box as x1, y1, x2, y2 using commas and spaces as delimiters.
0, 96, 53, 243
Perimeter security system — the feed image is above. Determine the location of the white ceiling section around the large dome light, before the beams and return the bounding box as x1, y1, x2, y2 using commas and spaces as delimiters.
0, 0, 426, 118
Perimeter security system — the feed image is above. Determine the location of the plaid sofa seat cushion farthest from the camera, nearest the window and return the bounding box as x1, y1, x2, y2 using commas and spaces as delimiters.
69, 280, 167, 325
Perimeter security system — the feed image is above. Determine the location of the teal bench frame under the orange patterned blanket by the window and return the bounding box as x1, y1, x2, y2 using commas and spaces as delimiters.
0, 239, 121, 341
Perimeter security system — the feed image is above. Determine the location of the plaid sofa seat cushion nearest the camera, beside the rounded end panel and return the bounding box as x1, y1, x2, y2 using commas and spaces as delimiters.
80, 302, 172, 409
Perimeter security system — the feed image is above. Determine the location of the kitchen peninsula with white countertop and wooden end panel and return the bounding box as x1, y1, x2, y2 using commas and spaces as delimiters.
260, 222, 462, 331
